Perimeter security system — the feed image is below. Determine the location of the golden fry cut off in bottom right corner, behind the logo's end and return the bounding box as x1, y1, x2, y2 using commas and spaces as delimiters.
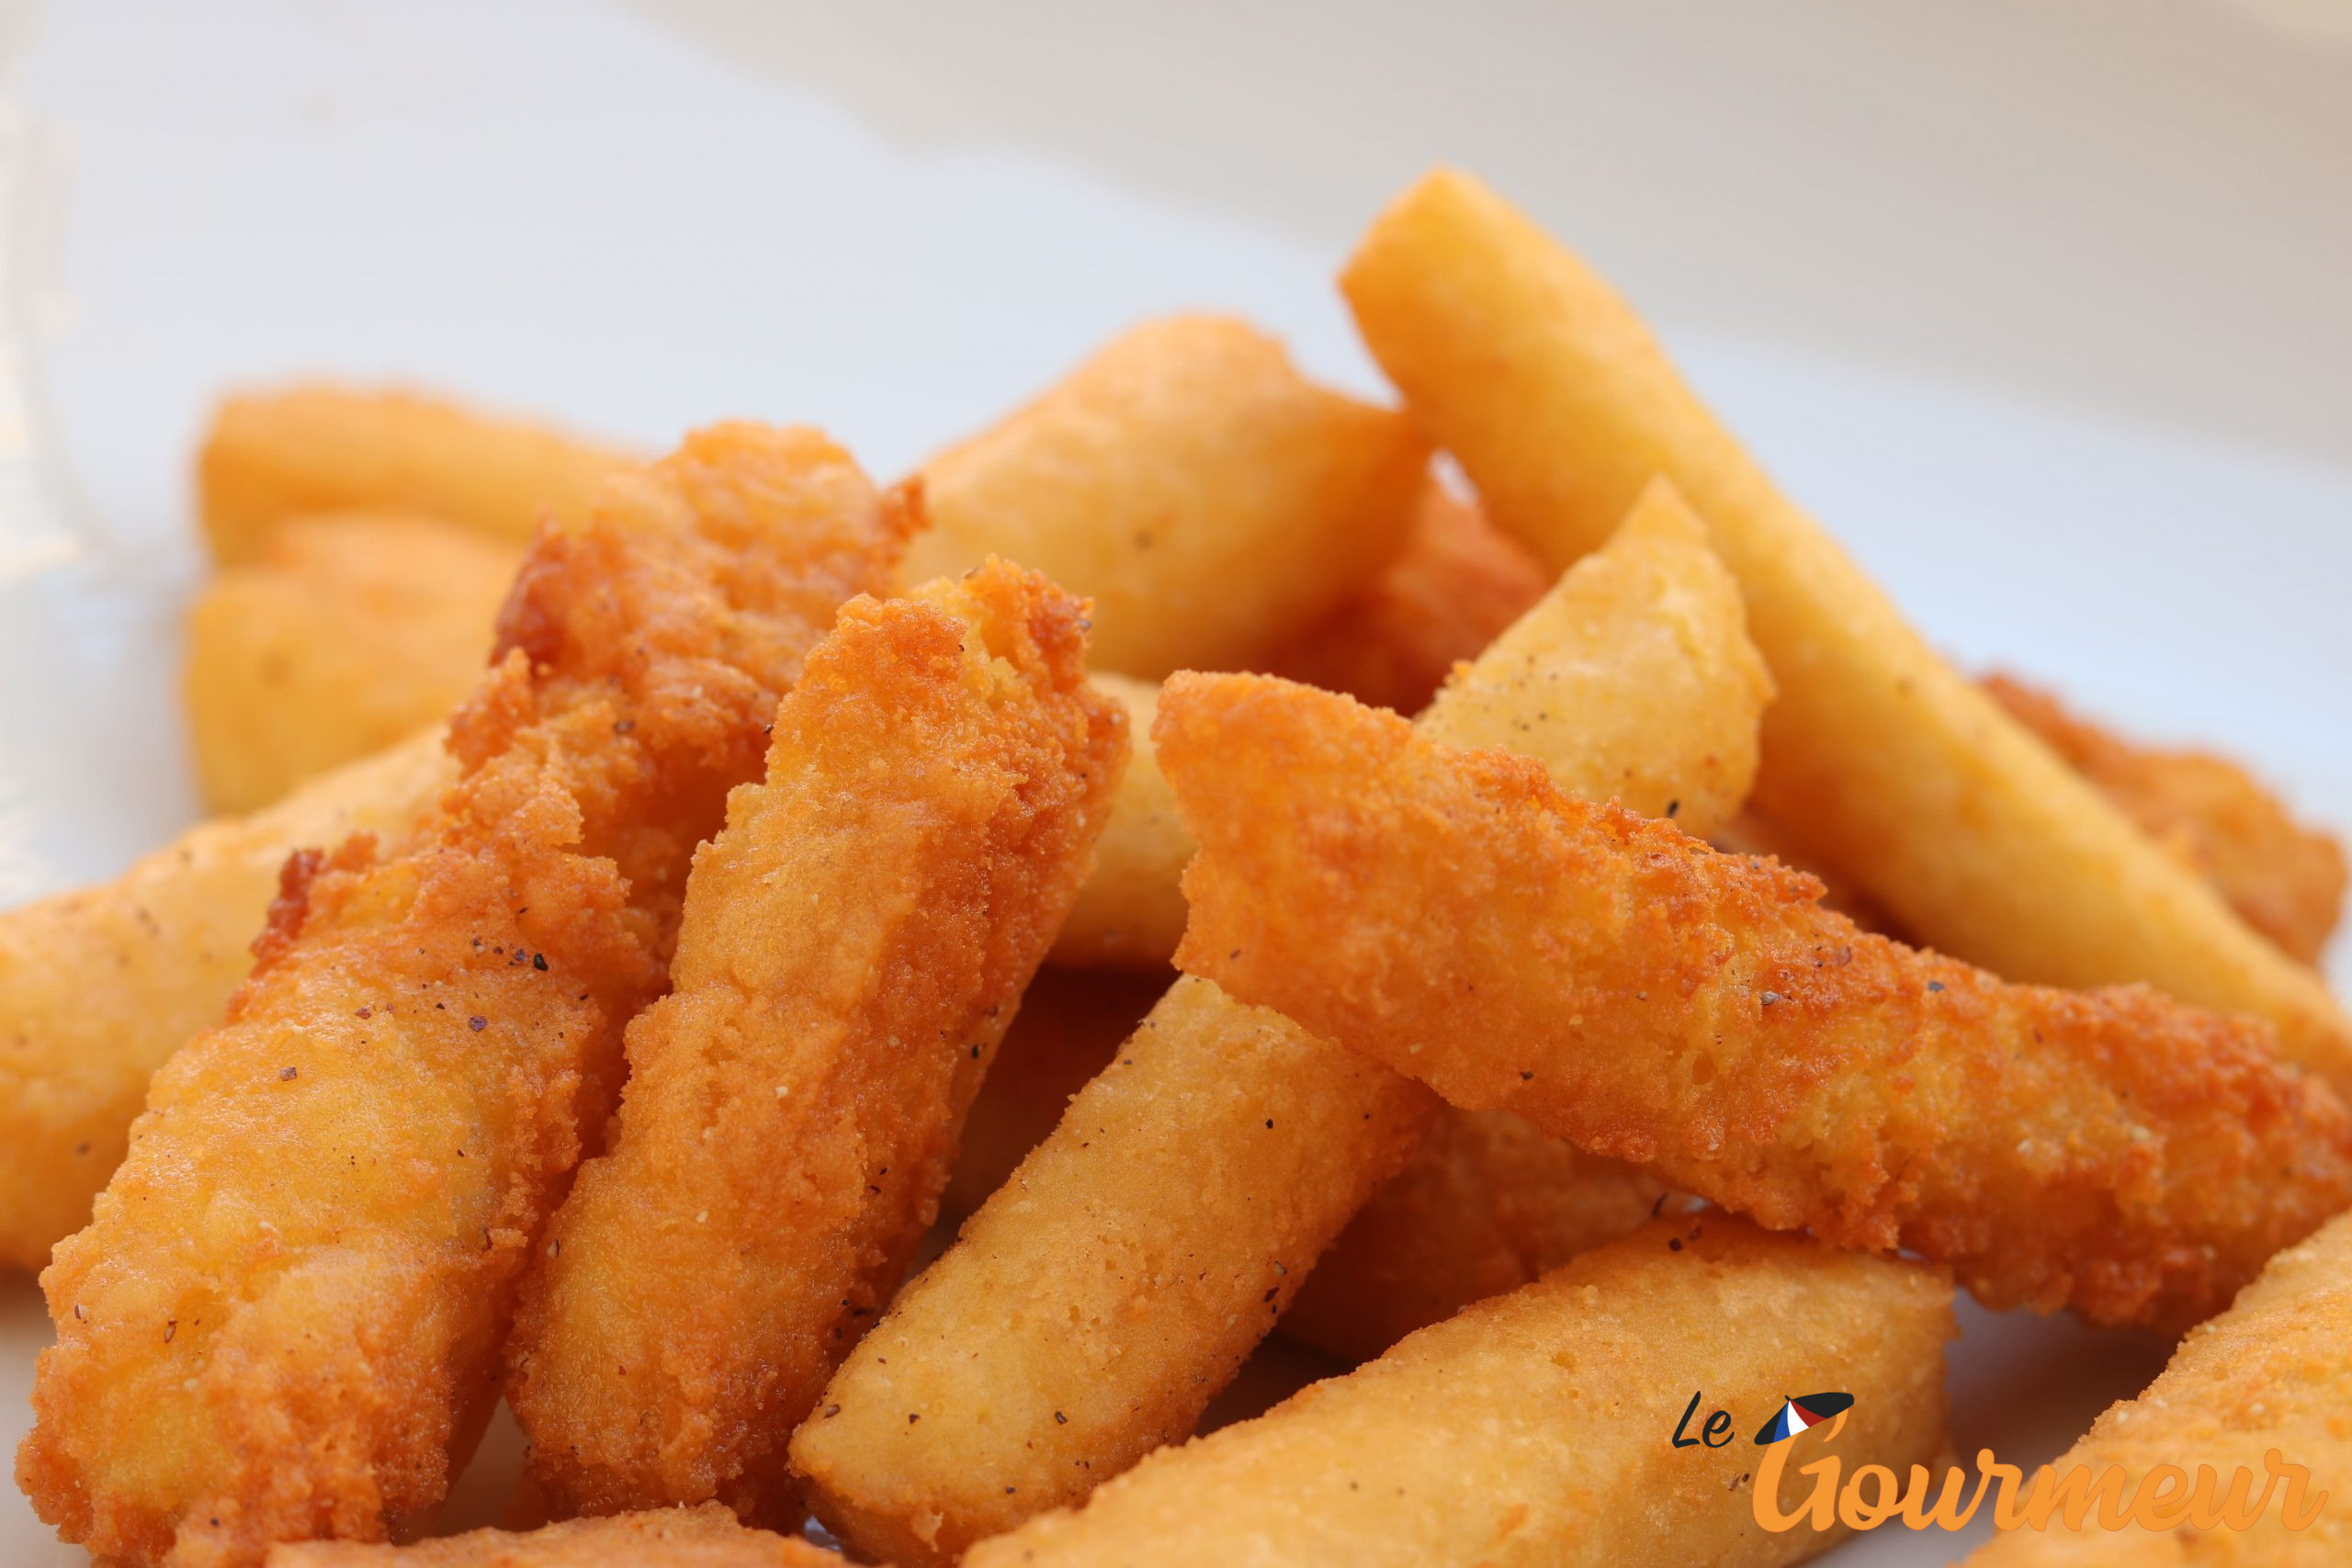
1969, 1218, 2352, 1568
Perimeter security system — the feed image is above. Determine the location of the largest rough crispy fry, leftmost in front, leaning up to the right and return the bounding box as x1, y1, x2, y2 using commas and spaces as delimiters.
17, 425, 908, 1568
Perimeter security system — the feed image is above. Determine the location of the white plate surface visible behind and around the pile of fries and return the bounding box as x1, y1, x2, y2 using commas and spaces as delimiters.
0, 0, 2352, 1568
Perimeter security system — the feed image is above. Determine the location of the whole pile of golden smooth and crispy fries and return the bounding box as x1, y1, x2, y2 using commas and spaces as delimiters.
0, 172, 2352, 1568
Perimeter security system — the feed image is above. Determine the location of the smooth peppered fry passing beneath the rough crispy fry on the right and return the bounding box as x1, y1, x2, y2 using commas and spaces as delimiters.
793, 489, 1767, 1563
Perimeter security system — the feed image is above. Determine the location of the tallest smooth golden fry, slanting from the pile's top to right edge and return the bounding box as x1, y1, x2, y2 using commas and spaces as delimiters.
1343, 172, 2352, 1084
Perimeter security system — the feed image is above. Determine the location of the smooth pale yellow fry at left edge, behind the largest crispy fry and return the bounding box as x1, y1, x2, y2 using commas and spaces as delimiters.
0, 728, 451, 1269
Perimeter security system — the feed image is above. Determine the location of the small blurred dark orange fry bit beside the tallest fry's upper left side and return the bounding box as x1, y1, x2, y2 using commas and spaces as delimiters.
1265, 478, 1553, 715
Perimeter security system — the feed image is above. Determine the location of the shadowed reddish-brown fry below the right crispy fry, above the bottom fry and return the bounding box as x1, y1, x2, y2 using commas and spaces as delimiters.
1282, 1105, 1668, 1361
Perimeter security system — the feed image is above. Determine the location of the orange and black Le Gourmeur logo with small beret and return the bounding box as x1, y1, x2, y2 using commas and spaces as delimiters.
1672, 1389, 2328, 1535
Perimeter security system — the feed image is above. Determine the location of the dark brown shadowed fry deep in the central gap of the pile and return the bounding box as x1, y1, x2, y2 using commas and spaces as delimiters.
938, 964, 1173, 1220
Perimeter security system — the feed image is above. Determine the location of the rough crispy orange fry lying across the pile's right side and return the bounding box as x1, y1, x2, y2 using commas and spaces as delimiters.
1158, 674, 2352, 1328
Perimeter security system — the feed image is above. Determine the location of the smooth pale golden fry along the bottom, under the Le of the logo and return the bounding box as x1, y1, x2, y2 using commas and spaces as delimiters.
965, 1215, 1954, 1568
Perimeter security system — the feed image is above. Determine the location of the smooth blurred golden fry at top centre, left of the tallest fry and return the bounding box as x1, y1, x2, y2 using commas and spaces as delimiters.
908, 315, 1428, 680
